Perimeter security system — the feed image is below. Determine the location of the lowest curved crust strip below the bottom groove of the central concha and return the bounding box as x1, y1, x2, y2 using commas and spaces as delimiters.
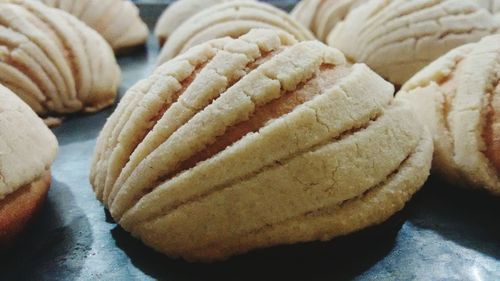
173, 122, 432, 261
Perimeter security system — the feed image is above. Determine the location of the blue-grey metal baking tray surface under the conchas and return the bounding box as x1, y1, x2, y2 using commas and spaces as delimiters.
0, 2, 500, 281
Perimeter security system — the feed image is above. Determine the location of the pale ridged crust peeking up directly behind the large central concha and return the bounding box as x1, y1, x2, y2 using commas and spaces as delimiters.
158, 0, 314, 64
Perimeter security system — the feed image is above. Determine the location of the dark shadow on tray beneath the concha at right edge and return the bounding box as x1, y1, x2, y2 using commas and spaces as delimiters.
410, 176, 500, 259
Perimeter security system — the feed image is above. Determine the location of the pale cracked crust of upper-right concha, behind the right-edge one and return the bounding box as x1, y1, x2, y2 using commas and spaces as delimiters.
327, 0, 500, 85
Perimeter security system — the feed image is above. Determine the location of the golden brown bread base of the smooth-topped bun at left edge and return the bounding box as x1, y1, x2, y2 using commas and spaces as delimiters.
0, 170, 51, 248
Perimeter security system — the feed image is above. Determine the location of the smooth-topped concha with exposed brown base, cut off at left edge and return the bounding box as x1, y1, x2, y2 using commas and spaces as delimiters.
0, 84, 57, 243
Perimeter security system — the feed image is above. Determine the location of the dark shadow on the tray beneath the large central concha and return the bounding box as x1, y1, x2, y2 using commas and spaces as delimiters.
105, 201, 408, 280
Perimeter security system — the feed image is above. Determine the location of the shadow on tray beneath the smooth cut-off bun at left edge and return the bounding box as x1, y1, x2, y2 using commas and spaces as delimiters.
0, 179, 94, 280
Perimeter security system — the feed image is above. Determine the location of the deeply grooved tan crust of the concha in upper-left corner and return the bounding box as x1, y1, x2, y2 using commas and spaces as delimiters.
0, 0, 120, 115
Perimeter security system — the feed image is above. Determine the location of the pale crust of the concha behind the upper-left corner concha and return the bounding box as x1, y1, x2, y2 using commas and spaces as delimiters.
42, 0, 149, 52
